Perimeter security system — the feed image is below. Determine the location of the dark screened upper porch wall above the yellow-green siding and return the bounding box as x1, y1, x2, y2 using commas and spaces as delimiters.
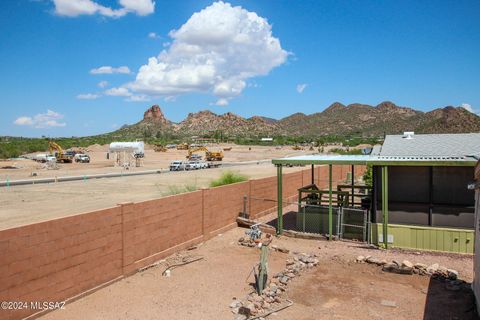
374, 166, 475, 229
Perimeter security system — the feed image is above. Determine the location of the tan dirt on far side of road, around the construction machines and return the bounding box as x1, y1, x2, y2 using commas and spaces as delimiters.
0, 144, 312, 180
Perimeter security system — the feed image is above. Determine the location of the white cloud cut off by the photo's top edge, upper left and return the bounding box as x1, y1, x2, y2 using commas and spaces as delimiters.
52, 0, 155, 18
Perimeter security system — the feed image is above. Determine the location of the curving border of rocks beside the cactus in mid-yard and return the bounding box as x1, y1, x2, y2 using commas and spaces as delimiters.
230, 254, 319, 320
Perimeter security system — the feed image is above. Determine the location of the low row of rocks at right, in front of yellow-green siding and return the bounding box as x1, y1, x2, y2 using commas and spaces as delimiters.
355, 256, 458, 281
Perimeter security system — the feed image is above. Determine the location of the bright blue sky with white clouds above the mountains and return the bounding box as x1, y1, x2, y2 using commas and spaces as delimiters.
0, 0, 480, 136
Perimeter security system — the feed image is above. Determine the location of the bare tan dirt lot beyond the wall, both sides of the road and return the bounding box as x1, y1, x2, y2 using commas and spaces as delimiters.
0, 144, 312, 230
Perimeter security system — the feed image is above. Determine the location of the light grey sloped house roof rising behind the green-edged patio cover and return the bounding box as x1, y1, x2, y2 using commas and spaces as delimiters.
378, 133, 480, 160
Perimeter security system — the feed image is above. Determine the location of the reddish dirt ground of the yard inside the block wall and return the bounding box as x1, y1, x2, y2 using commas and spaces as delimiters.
41, 228, 476, 320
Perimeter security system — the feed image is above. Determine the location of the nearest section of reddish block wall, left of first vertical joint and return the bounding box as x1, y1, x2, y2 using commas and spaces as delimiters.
0, 207, 122, 319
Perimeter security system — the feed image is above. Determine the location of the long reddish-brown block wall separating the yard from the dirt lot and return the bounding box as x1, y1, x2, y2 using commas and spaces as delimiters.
0, 166, 363, 319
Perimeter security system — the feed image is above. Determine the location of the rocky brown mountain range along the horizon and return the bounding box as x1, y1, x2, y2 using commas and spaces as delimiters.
117, 101, 480, 137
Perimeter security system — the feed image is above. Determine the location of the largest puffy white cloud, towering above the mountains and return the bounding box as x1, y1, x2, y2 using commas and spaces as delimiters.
126, 2, 288, 102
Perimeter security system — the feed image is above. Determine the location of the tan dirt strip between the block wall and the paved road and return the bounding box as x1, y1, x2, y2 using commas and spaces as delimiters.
0, 163, 303, 230
